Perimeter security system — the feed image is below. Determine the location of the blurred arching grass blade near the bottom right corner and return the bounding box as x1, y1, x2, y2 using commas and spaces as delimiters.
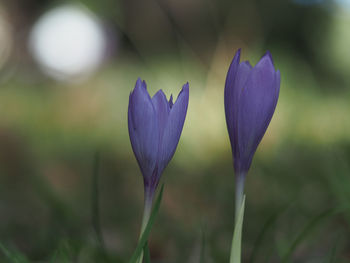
281, 209, 335, 263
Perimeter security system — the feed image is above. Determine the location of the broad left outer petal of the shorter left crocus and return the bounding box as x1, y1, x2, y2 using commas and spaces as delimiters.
128, 79, 159, 178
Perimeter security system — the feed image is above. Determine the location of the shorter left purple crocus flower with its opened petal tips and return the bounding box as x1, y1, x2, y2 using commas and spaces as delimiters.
128, 78, 189, 205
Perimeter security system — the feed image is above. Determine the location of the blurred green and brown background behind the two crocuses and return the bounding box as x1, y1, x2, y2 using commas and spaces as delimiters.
0, 0, 350, 263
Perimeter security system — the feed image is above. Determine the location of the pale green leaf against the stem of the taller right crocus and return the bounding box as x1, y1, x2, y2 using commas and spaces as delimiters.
230, 195, 245, 263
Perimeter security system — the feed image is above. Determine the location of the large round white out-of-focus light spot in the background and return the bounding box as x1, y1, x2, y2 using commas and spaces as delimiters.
29, 5, 106, 80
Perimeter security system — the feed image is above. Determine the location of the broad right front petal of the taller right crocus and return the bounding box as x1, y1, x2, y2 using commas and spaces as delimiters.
234, 53, 279, 172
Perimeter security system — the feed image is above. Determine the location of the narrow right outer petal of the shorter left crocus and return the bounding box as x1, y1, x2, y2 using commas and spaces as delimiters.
158, 83, 189, 172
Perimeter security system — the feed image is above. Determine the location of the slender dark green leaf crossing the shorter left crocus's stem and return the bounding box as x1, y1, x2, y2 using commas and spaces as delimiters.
129, 184, 164, 263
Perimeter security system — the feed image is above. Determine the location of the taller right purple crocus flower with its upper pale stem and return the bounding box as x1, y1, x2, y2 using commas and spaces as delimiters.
224, 50, 280, 219
